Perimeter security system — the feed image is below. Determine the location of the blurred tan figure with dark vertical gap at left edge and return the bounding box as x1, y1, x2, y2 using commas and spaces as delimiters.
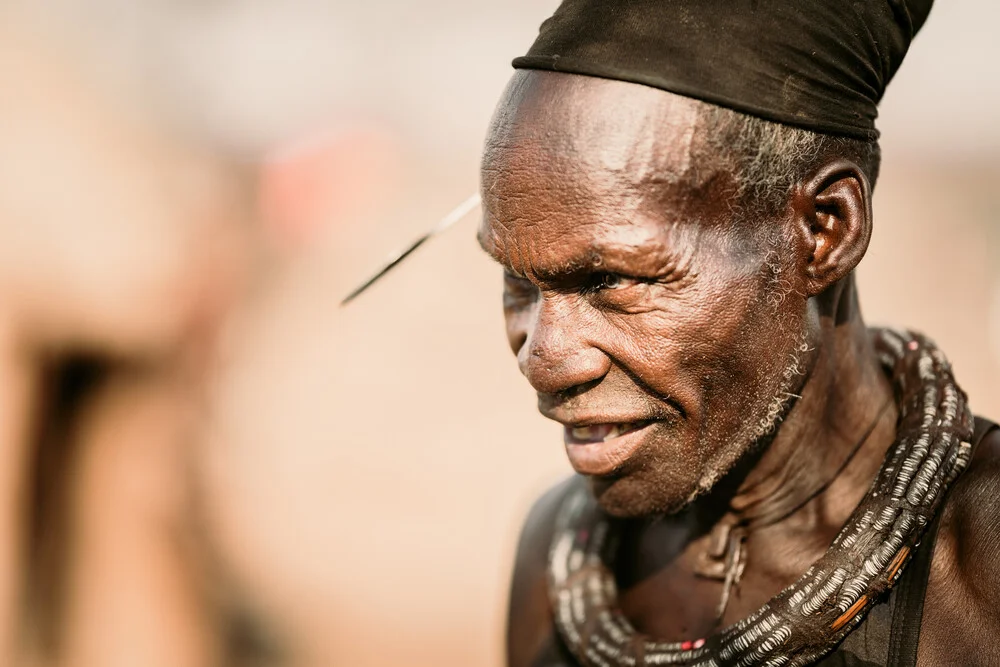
0, 14, 249, 665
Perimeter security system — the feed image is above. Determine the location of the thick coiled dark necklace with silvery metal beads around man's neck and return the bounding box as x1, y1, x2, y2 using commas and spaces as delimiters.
549, 330, 973, 667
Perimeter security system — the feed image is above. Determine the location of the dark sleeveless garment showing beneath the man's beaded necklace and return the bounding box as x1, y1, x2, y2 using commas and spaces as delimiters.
532, 417, 998, 667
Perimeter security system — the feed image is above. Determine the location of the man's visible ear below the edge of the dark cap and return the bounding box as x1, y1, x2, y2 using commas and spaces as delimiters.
795, 160, 872, 296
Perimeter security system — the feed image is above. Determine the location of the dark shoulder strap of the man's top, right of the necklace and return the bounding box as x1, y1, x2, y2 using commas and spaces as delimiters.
886, 417, 998, 667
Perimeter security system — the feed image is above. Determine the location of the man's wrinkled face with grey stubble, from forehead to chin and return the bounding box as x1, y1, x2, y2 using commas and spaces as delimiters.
480, 72, 812, 516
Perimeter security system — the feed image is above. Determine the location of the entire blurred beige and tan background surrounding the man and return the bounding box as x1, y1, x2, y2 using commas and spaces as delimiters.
0, 0, 1000, 667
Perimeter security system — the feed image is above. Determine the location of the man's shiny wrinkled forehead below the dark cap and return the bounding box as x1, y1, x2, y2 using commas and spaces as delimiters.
480, 71, 732, 253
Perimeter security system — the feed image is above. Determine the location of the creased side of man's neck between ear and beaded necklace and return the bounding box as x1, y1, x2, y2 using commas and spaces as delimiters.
730, 281, 897, 540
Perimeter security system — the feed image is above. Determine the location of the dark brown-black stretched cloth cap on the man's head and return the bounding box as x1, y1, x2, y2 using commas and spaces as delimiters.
514, 0, 933, 140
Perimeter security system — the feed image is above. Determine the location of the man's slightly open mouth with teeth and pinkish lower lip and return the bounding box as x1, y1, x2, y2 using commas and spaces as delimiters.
564, 420, 655, 477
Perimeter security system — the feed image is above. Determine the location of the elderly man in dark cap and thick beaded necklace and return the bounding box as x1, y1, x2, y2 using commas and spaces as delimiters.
479, 0, 1000, 667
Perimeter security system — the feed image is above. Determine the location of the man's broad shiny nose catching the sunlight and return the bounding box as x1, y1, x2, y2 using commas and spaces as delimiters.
517, 295, 611, 394
